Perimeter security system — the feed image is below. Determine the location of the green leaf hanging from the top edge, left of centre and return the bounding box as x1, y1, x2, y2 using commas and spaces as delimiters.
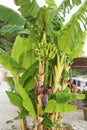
14, 0, 40, 21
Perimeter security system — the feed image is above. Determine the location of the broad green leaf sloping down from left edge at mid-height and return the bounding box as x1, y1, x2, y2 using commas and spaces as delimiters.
0, 49, 25, 74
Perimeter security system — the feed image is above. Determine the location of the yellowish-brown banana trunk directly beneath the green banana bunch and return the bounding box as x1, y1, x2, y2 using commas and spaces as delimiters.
33, 60, 44, 130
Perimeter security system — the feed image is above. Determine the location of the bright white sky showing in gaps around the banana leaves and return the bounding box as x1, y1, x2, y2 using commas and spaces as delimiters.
0, 0, 87, 56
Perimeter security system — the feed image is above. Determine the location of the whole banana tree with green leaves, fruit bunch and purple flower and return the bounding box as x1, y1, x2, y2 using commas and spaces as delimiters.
0, 0, 87, 130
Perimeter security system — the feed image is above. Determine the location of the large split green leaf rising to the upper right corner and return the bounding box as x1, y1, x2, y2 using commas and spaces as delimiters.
58, 2, 87, 54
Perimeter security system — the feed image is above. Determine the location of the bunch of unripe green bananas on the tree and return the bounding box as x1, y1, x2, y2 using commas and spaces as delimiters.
35, 42, 57, 60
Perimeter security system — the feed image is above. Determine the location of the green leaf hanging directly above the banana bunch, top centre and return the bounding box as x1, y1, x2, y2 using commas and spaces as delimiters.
35, 7, 59, 42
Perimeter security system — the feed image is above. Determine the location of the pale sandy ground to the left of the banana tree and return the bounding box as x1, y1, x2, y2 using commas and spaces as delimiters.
0, 82, 20, 130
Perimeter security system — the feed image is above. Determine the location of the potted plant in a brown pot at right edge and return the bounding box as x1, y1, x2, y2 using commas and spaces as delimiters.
82, 90, 87, 121
